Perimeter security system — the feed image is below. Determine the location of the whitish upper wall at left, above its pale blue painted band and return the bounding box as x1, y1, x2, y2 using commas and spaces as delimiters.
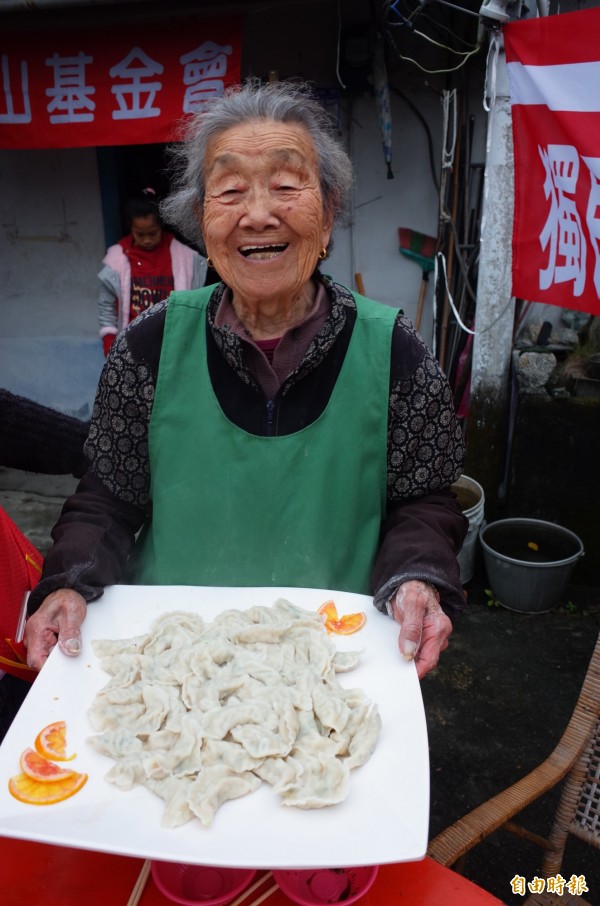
0, 148, 104, 337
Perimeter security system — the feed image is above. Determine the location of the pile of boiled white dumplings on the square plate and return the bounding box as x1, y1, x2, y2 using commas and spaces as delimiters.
89, 599, 381, 827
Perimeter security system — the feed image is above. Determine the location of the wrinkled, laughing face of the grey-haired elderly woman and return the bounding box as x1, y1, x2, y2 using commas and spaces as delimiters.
201, 120, 331, 304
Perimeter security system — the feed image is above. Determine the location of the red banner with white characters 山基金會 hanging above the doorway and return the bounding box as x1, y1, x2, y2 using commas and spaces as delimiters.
0, 18, 241, 148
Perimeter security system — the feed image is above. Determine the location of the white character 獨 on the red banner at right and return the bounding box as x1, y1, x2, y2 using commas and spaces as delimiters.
538, 145, 586, 296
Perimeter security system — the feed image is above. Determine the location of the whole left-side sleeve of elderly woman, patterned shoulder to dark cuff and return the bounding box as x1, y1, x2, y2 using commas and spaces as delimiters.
28, 304, 165, 613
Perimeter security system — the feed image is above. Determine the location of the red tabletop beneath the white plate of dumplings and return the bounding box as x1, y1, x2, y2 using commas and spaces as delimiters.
0, 837, 508, 906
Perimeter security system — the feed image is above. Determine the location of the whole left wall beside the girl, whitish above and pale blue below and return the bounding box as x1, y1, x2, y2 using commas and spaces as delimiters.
0, 148, 104, 418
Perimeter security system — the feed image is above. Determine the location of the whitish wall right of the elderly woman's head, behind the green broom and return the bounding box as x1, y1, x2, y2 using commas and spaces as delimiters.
325, 86, 485, 346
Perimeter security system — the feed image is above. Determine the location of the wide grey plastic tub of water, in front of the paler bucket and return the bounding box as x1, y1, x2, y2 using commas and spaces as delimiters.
479, 519, 584, 613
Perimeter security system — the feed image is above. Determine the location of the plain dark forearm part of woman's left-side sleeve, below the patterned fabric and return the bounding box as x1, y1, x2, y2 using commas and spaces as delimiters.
28, 472, 146, 614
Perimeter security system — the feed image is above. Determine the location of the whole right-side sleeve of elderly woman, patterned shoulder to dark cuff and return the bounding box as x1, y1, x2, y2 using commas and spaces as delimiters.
372, 316, 469, 619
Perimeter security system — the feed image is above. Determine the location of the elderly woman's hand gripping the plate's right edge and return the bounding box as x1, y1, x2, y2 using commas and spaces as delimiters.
392, 579, 452, 679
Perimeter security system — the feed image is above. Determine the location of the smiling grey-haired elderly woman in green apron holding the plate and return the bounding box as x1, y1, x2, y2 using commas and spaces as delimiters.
26, 82, 467, 677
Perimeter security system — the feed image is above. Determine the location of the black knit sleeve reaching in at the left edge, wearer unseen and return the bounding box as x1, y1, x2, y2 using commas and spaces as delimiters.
0, 390, 88, 478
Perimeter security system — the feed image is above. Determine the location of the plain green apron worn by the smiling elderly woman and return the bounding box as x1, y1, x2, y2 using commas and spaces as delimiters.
131, 287, 397, 594
